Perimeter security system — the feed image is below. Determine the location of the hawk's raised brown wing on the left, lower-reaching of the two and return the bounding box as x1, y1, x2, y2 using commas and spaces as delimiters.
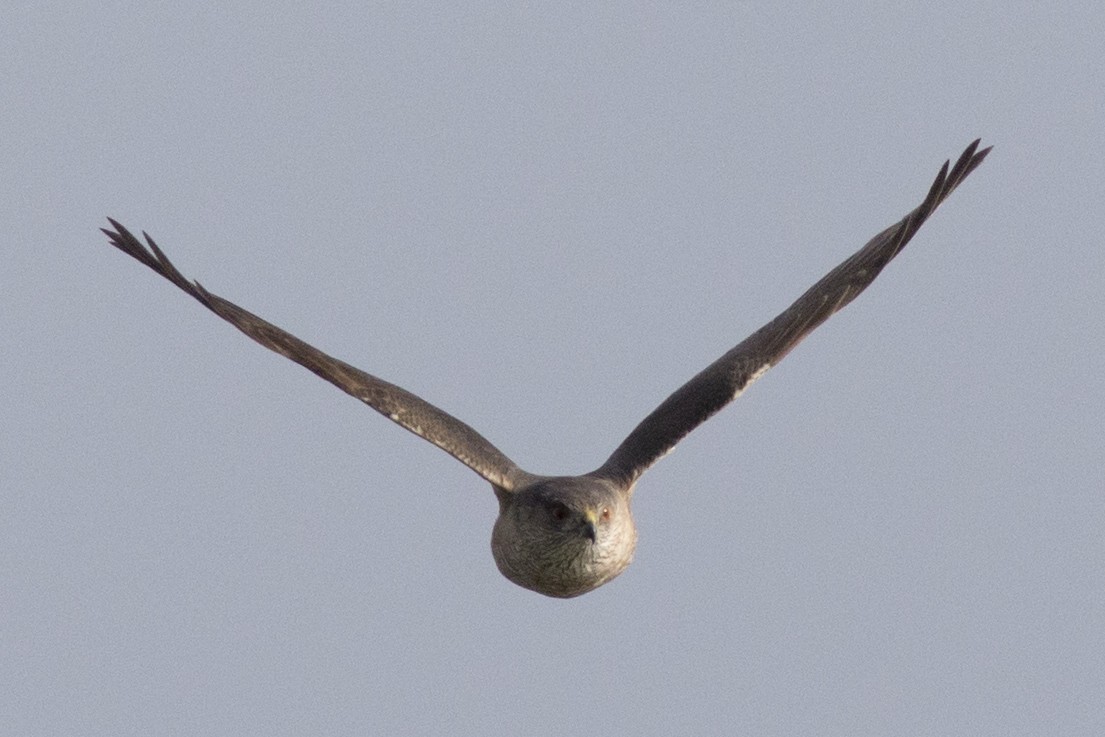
101, 218, 532, 492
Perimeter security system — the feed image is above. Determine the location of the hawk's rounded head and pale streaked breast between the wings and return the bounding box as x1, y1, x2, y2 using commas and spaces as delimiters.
491, 476, 636, 599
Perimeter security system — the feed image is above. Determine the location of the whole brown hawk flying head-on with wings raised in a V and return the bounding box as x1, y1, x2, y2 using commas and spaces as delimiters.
102, 140, 990, 598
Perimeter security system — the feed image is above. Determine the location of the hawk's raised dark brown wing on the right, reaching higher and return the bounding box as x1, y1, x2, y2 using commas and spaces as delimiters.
593, 140, 990, 488
